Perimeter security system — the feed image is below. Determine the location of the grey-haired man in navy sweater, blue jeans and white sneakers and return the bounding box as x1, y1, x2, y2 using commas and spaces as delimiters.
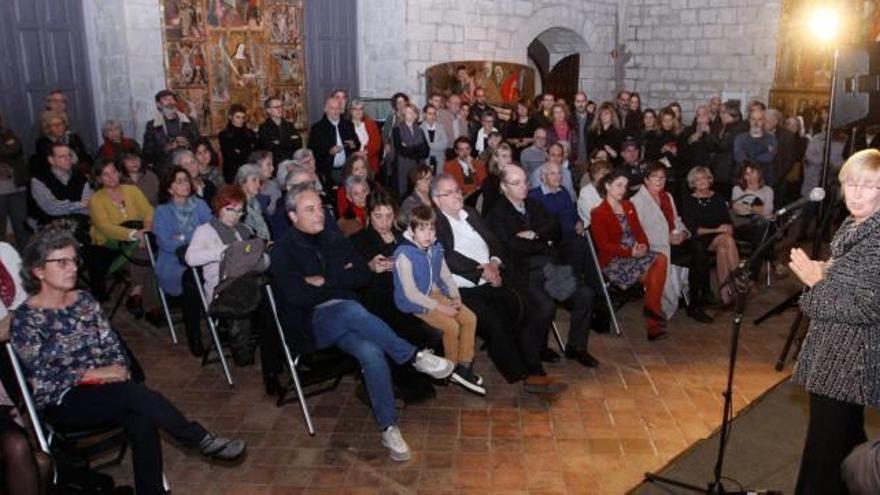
270, 184, 453, 461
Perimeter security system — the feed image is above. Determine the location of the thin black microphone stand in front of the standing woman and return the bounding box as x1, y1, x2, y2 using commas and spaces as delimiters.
645, 211, 800, 495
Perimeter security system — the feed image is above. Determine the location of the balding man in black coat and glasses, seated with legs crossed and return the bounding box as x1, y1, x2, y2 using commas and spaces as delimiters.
486, 165, 599, 367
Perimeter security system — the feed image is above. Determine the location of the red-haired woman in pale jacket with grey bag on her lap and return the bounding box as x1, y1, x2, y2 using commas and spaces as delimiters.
185, 185, 256, 366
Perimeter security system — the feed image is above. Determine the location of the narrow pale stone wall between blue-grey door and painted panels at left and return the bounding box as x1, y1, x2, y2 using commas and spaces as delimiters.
83, 0, 165, 141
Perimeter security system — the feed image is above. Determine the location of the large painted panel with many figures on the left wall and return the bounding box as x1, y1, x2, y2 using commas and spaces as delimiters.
160, 0, 308, 136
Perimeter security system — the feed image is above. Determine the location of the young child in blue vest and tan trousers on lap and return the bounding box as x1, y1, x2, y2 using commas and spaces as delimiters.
394, 205, 486, 395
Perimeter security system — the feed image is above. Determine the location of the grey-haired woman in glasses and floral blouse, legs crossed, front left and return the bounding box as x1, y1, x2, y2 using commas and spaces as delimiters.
11, 227, 245, 494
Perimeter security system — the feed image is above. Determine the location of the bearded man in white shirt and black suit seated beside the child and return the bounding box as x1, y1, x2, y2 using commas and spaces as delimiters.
431, 174, 563, 393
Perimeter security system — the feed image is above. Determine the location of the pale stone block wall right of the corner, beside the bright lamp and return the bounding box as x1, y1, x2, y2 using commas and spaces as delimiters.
620, 0, 781, 115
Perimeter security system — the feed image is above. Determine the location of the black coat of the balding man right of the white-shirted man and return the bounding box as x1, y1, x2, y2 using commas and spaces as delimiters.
486, 198, 562, 293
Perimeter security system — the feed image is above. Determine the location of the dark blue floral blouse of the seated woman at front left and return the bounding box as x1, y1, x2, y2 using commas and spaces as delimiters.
10, 291, 128, 409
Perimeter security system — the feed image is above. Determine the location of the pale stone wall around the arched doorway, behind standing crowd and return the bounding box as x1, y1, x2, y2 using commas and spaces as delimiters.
358, 0, 617, 101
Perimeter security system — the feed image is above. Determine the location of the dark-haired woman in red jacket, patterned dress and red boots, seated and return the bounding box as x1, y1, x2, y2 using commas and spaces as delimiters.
590, 170, 667, 340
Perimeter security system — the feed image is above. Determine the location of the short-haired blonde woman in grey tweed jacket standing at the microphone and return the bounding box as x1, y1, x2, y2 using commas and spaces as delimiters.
789, 149, 880, 495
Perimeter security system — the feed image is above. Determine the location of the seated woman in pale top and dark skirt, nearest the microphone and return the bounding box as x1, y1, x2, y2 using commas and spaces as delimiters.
730, 160, 786, 280
